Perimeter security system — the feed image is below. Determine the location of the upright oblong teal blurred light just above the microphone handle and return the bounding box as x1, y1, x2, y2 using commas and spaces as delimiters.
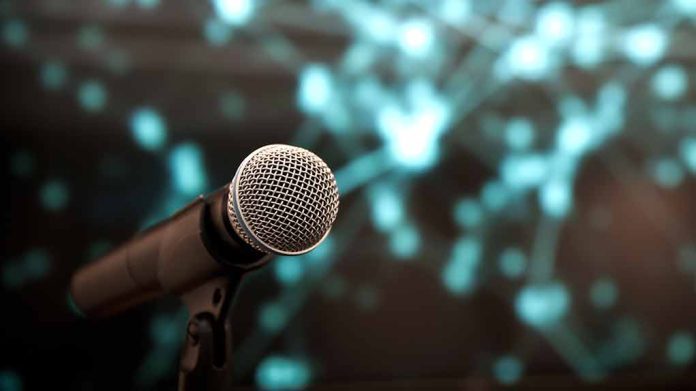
169, 143, 208, 196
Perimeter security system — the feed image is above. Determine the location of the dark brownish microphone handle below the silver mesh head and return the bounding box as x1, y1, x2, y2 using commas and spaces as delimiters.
70, 186, 270, 317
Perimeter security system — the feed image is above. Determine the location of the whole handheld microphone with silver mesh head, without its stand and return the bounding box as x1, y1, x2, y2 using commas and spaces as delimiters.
70, 144, 339, 317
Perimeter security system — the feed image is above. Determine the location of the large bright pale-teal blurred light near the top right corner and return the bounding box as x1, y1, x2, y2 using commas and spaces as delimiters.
623, 24, 669, 66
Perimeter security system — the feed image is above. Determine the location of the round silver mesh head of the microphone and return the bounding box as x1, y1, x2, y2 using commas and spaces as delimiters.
227, 144, 338, 255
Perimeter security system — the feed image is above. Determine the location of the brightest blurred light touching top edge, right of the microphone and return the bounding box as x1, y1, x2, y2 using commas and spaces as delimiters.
536, 2, 575, 45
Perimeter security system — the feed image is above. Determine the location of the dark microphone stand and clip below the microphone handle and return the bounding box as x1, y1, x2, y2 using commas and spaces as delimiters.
179, 272, 242, 391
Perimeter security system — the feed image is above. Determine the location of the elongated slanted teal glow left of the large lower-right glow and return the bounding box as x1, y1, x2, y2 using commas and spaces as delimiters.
442, 237, 482, 295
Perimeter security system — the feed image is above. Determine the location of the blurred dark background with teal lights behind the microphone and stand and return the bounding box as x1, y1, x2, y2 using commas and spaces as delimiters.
0, 0, 696, 391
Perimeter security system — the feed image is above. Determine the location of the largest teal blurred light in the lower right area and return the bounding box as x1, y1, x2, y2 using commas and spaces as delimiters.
515, 282, 570, 328
